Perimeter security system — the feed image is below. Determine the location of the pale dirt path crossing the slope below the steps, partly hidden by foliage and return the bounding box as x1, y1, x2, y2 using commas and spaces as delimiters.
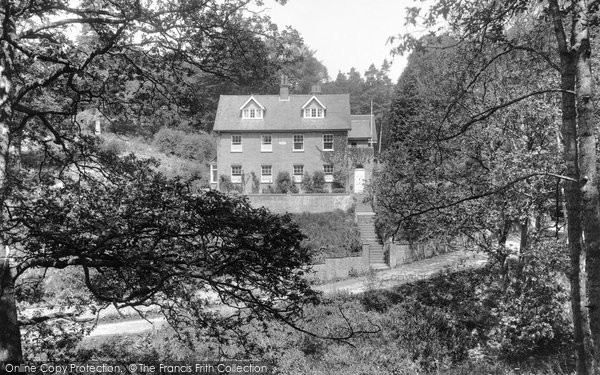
89, 251, 486, 337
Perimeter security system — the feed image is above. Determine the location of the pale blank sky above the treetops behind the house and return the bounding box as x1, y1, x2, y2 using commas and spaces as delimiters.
264, 0, 422, 82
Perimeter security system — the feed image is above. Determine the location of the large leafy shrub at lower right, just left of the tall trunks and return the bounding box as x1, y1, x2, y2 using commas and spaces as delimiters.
482, 243, 571, 361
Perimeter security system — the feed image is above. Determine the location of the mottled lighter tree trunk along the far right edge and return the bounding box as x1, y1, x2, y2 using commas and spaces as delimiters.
574, 0, 600, 368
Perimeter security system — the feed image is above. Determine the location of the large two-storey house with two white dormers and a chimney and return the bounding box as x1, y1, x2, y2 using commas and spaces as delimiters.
210, 77, 377, 192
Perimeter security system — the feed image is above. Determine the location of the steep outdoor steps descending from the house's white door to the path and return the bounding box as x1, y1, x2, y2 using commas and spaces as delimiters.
355, 195, 388, 269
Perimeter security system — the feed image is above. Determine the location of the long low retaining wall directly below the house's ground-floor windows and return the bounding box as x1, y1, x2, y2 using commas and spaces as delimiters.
248, 194, 354, 213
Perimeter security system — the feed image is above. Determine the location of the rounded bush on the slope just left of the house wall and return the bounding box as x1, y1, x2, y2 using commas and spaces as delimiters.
153, 128, 216, 163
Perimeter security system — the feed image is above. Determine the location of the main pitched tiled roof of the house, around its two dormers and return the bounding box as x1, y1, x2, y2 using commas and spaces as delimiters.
213, 94, 351, 131
